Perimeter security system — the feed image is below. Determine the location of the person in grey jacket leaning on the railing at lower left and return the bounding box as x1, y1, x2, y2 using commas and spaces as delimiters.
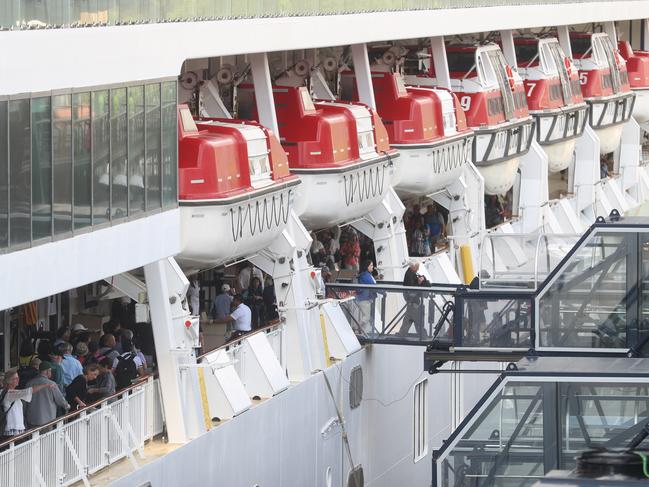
27, 362, 70, 428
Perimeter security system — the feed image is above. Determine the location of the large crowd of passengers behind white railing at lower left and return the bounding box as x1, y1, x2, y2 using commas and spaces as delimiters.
0, 322, 147, 443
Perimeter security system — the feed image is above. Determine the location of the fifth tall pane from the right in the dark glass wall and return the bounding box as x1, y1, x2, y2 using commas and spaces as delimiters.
92, 90, 110, 225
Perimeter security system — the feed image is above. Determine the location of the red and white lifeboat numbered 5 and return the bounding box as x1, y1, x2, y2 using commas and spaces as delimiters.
570, 32, 634, 154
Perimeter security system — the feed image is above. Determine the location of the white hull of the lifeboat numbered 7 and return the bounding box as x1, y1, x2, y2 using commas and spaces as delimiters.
532, 103, 588, 173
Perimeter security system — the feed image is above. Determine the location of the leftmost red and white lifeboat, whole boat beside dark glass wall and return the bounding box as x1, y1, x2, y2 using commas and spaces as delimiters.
178, 105, 300, 272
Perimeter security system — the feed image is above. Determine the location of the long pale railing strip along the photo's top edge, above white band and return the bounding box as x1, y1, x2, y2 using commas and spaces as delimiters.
0, 0, 628, 29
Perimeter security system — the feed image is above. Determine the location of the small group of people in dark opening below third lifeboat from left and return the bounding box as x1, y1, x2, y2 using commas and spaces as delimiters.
403, 203, 446, 257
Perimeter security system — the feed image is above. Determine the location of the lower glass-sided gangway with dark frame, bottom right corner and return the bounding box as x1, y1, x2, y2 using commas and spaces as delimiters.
432, 357, 649, 487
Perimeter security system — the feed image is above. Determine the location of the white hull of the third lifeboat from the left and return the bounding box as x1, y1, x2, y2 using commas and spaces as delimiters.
392, 134, 473, 196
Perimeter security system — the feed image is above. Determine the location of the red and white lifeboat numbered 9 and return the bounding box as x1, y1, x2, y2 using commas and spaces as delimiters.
406, 44, 534, 194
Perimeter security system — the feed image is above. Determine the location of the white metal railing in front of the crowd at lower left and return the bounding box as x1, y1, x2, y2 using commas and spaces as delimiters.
0, 378, 164, 487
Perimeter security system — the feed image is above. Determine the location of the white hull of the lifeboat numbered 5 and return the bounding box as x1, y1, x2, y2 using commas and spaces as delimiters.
587, 93, 635, 155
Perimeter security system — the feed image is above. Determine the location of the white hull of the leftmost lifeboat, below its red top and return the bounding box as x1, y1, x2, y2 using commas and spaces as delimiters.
177, 179, 300, 273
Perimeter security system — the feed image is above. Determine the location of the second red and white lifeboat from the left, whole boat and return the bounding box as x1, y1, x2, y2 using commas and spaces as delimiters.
239, 85, 399, 228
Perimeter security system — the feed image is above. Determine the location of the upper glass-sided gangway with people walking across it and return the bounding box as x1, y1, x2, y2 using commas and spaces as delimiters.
327, 214, 649, 373
